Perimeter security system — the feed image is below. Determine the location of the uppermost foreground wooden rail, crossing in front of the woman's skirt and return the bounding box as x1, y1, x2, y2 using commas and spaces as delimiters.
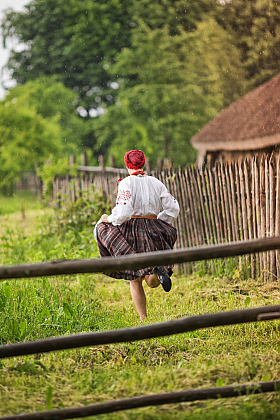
0, 237, 280, 280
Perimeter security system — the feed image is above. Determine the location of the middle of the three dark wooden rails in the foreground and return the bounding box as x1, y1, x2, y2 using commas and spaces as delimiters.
0, 305, 280, 359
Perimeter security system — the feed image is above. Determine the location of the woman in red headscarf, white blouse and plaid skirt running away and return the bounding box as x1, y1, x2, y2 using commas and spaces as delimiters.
95, 150, 180, 320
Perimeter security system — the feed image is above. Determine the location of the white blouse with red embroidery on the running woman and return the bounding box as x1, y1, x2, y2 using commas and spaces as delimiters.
108, 175, 180, 226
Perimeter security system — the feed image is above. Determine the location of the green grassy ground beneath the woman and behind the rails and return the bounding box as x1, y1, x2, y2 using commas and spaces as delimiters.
0, 195, 280, 420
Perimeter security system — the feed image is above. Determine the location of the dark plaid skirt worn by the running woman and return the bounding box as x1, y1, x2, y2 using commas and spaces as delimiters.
96, 218, 177, 280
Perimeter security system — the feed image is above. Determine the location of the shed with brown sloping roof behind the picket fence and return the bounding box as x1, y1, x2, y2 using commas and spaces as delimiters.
191, 74, 280, 167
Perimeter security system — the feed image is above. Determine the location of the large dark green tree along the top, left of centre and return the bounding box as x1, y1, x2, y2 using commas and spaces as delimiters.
2, 0, 219, 111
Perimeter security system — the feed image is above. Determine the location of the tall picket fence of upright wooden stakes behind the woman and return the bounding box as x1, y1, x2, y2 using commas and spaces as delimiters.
53, 154, 280, 281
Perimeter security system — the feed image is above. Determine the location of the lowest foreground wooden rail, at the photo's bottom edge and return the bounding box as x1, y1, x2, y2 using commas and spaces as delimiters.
0, 381, 280, 420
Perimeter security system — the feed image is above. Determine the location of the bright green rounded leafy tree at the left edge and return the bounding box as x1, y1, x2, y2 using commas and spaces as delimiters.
0, 77, 88, 192
